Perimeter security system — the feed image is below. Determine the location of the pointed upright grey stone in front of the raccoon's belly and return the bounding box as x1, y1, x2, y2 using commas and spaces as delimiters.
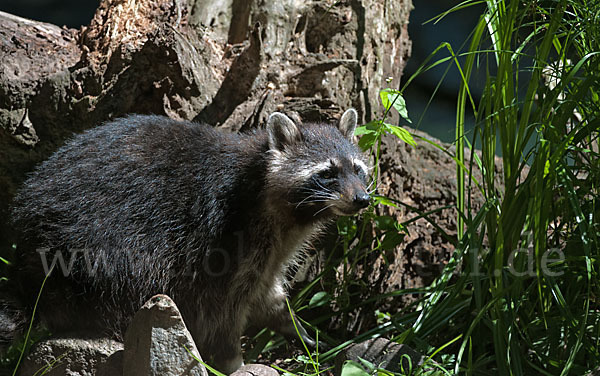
123, 295, 208, 376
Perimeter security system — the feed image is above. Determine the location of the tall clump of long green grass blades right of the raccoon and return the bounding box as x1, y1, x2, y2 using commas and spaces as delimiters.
406, 0, 600, 375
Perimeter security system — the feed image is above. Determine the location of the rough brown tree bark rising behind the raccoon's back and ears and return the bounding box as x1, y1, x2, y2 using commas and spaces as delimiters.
0, 0, 411, 246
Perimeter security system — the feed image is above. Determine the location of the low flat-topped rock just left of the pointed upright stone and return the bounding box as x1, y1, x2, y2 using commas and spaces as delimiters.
19, 338, 123, 376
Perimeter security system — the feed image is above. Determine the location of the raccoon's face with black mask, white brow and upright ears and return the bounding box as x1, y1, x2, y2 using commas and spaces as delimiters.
267, 109, 370, 221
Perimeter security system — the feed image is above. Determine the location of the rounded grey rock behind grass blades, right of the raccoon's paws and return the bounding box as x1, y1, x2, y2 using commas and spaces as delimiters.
335, 338, 425, 375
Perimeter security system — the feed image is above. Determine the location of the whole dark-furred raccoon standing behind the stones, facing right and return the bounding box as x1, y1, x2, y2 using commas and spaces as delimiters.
3, 109, 370, 373
